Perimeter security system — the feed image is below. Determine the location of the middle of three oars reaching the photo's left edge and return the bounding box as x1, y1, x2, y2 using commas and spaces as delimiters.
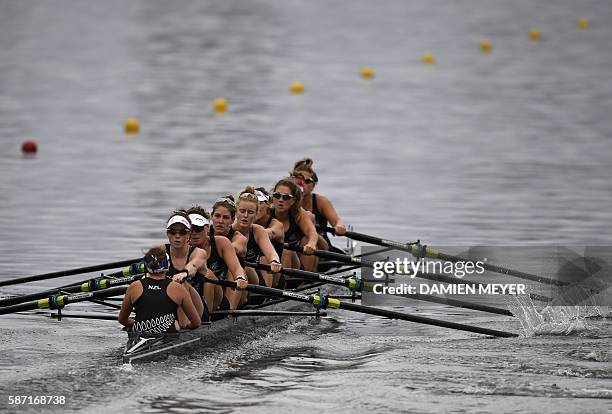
0, 262, 144, 307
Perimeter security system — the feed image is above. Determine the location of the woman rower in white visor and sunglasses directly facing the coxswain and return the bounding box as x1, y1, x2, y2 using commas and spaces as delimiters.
165, 210, 212, 323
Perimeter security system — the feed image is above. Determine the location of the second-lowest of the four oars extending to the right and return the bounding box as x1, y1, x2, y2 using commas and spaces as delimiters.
245, 262, 514, 316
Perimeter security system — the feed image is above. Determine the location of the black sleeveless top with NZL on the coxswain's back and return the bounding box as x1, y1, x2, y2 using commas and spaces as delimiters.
132, 277, 178, 334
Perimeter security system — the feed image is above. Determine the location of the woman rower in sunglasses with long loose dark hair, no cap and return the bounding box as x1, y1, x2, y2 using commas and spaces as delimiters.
270, 178, 319, 272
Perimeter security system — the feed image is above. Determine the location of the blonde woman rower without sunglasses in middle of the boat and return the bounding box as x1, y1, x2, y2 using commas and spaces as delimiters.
231, 187, 281, 287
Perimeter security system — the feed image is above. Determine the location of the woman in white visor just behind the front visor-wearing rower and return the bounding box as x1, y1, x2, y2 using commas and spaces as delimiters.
187, 205, 247, 310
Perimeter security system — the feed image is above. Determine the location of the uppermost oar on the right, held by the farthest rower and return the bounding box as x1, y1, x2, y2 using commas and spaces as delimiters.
323, 227, 568, 286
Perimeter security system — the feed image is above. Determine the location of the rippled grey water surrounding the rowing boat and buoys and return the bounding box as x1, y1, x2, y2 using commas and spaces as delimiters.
0, 0, 612, 412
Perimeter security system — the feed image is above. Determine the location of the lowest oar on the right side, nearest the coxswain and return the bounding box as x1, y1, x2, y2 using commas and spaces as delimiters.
204, 277, 518, 337
